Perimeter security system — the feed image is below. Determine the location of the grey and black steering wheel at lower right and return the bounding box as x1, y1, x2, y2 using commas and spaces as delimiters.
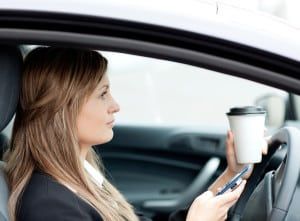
227, 127, 300, 221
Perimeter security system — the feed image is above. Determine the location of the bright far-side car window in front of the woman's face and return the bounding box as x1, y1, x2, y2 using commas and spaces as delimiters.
101, 52, 287, 129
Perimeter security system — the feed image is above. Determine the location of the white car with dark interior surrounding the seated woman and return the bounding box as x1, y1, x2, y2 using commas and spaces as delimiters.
0, 0, 300, 221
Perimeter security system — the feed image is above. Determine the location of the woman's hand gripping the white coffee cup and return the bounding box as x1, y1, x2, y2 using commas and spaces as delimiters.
226, 131, 268, 179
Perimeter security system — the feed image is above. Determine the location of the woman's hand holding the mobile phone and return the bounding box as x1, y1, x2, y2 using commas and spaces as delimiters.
186, 180, 246, 221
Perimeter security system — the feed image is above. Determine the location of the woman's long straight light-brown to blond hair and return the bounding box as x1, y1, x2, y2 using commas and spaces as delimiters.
5, 47, 138, 221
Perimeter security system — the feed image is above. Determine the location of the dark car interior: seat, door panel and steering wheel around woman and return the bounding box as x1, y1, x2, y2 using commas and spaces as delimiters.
0, 39, 300, 221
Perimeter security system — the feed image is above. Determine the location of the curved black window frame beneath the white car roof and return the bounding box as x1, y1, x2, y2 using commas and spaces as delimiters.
0, 10, 300, 94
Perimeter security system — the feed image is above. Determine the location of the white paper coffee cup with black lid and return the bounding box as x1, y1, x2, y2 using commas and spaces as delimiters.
227, 106, 266, 164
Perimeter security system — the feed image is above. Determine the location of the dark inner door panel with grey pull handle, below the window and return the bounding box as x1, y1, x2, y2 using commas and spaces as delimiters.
97, 126, 224, 218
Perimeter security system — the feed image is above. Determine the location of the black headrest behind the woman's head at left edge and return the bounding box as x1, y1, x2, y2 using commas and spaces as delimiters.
0, 45, 23, 131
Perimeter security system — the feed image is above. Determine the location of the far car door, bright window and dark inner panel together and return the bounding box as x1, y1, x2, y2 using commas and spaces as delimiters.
95, 51, 288, 220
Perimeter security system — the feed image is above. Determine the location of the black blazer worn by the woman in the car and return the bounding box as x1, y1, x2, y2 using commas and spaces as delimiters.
17, 171, 186, 221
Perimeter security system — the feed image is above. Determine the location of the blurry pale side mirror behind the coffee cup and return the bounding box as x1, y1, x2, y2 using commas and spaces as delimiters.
255, 94, 287, 128
